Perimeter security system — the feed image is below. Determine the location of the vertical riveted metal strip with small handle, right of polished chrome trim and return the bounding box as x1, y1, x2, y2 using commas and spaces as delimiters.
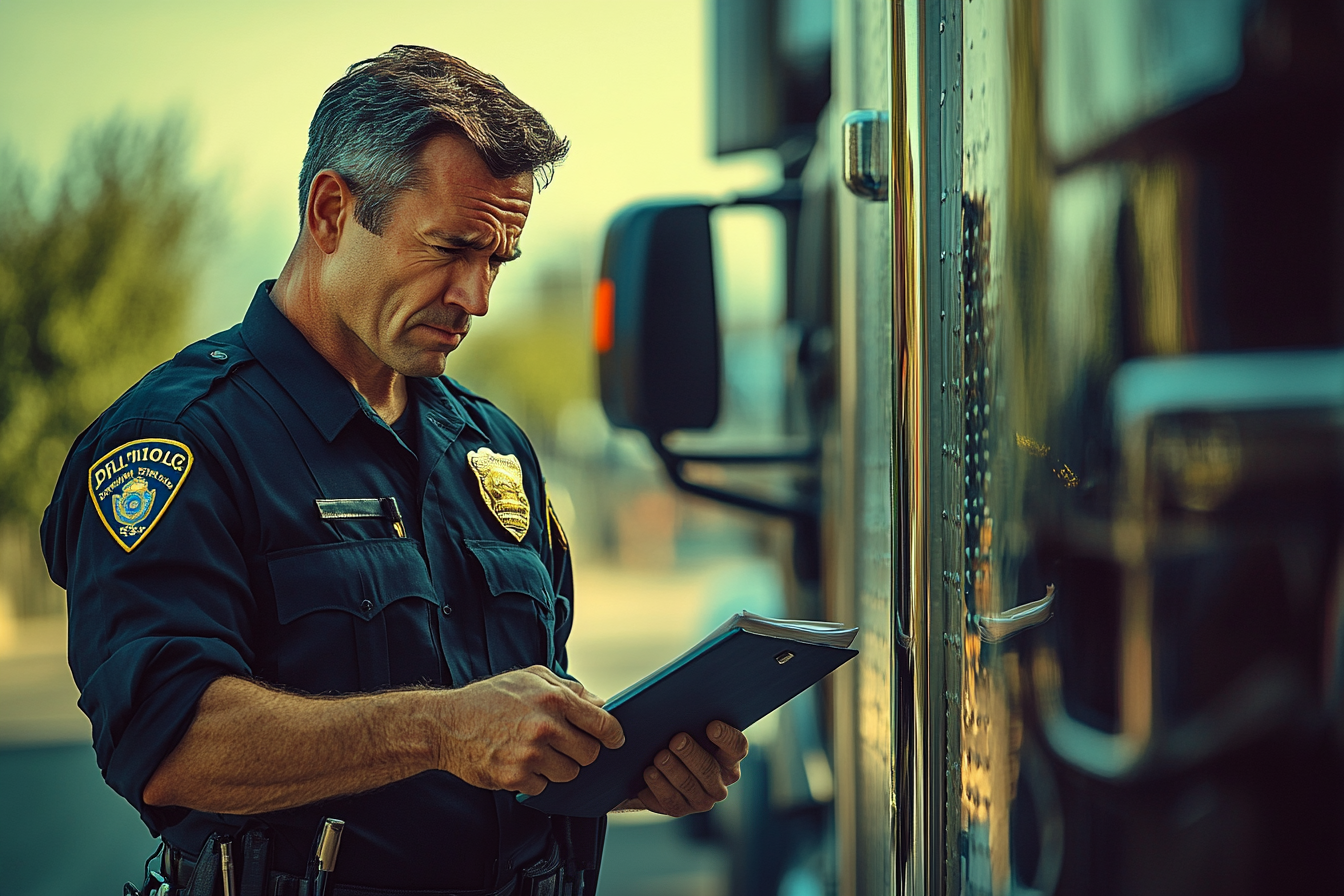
962, 0, 1053, 896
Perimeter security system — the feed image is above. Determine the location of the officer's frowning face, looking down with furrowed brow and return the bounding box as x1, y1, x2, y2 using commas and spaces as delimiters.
328, 134, 532, 376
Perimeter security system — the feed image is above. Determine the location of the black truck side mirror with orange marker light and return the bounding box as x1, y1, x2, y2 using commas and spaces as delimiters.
593, 203, 722, 443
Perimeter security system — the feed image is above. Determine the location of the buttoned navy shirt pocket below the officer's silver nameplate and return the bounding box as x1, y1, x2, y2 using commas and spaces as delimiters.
260, 539, 438, 693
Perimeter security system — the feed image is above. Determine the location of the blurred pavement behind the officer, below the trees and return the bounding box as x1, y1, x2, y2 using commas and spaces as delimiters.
0, 560, 751, 896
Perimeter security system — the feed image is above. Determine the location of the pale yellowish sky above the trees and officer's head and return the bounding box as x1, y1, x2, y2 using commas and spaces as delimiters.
0, 0, 774, 337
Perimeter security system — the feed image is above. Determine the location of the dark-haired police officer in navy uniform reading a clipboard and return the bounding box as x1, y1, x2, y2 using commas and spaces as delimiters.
43, 47, 746, 896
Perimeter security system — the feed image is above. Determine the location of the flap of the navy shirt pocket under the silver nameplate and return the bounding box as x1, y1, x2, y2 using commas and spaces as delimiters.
266, 539, 435, 625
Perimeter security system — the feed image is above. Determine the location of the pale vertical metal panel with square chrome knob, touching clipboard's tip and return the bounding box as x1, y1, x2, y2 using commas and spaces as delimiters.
823, 0, 898, 896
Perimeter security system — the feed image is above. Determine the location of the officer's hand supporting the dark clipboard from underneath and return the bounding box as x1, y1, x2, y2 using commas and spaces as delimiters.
617, 721, 747, 818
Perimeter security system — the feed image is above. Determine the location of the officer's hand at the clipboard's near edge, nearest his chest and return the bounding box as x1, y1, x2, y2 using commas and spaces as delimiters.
437, 666, 623, 799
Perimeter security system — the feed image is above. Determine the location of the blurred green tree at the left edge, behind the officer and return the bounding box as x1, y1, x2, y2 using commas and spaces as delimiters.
0, 118, 203, 529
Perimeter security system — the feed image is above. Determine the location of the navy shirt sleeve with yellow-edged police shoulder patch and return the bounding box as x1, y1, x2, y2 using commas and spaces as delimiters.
43, 420, 255, 834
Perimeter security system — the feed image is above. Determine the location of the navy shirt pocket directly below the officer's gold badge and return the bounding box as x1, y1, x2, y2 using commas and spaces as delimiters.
465, 540, 555, 674
